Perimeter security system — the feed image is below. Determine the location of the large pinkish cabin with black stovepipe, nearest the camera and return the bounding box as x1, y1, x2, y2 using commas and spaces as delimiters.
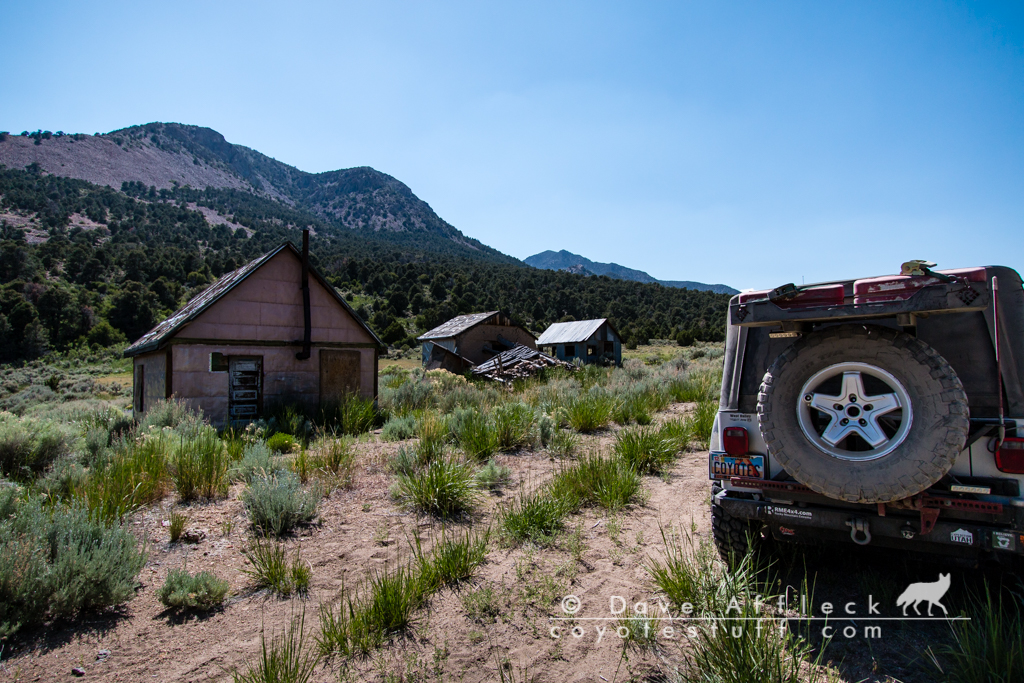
125, 232, 384, 427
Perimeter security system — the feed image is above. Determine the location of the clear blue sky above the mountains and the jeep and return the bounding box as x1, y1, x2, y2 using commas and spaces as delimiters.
0, 1, 1024, 288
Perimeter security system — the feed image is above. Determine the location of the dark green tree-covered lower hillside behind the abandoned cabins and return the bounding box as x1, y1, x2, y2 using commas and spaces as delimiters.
0, 167, 728, 361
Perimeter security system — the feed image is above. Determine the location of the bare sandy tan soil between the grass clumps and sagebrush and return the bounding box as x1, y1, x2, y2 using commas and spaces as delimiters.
0, 404, 974, 682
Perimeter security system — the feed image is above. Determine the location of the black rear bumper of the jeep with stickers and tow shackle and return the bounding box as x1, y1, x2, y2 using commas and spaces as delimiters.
716, 492, 1024, 558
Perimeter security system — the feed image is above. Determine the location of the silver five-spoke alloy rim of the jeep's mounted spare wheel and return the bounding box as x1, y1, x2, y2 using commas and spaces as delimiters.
797, 362, 913, 461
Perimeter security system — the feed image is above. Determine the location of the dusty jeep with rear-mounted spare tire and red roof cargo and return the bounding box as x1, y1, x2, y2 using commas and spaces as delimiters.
709, 261, 1024, 563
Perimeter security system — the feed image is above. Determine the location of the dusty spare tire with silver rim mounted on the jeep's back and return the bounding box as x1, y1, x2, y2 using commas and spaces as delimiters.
758, 326, 970, 503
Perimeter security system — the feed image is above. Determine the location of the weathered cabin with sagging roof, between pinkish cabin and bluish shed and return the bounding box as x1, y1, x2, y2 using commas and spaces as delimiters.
416, 310, 537, 374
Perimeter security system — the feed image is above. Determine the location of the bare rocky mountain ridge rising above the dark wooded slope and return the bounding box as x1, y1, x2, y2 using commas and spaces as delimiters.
0, 123, 503, 262
